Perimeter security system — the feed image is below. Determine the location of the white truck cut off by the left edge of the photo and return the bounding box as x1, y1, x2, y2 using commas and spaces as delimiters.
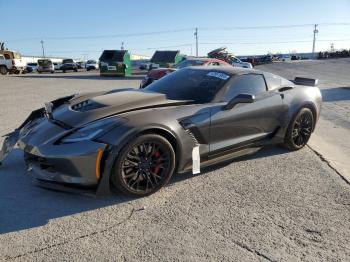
0, 50, 27, 75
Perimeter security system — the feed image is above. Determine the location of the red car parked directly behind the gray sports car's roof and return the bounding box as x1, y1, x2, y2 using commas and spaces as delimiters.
140, 58, 231, 88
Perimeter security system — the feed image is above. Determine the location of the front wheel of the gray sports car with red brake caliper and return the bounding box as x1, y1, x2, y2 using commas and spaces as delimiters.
111, 134, 175, 197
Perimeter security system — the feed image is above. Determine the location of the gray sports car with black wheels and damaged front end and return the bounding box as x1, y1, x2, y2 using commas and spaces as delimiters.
0, 67, 322, 196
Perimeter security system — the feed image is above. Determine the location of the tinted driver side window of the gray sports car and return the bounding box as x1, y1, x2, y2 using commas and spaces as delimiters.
222, 74, 266, 102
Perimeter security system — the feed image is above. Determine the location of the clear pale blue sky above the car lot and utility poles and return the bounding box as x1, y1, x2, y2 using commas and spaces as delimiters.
0, 0, 350, 59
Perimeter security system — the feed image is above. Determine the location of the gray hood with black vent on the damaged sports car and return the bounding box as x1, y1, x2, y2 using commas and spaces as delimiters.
53, 89, 191, 127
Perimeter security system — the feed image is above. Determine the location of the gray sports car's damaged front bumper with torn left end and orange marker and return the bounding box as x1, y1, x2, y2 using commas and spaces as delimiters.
0, 97, 111, 195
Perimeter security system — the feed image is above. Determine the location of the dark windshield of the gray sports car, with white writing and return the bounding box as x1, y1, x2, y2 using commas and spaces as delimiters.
144, 68, 230, 104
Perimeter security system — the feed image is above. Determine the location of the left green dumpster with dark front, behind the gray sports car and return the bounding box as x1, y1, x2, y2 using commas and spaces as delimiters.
99, 50, 132, 76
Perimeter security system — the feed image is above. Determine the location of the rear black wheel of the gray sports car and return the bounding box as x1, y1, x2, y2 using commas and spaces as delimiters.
284, 108, 315, 151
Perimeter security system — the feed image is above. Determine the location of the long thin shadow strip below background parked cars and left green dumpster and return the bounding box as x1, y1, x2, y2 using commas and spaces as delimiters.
13, 73, 144, 81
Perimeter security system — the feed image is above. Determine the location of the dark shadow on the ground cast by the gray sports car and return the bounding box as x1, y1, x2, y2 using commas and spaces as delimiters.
0, 147, 288, 234
